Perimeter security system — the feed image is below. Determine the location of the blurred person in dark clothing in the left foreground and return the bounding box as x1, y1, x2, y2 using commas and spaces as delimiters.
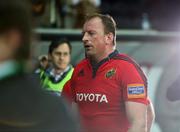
0, 0, 78, 132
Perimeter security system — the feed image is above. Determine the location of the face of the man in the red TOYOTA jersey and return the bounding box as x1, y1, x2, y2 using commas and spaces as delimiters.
82, 17, 106, 58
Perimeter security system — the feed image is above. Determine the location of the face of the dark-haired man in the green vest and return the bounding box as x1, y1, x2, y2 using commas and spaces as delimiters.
50, 43, 70, 70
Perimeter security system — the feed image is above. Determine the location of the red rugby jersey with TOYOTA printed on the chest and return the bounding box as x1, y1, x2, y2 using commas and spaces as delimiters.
63, 51, 149, 132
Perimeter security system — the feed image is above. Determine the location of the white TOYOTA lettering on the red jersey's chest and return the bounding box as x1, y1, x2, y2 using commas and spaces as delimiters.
76, 93, 108, 103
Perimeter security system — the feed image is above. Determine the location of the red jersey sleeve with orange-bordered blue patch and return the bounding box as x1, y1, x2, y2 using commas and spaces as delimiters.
122, 62, 149, 105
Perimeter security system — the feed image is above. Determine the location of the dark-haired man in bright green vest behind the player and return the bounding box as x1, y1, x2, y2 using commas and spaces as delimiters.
40, 39, 74, 96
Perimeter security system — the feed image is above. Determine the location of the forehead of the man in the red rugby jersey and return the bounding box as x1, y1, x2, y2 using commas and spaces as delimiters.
83, 17, 104, 31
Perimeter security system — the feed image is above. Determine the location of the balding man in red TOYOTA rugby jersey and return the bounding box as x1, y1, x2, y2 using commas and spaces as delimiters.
63, 14, 154, 132
